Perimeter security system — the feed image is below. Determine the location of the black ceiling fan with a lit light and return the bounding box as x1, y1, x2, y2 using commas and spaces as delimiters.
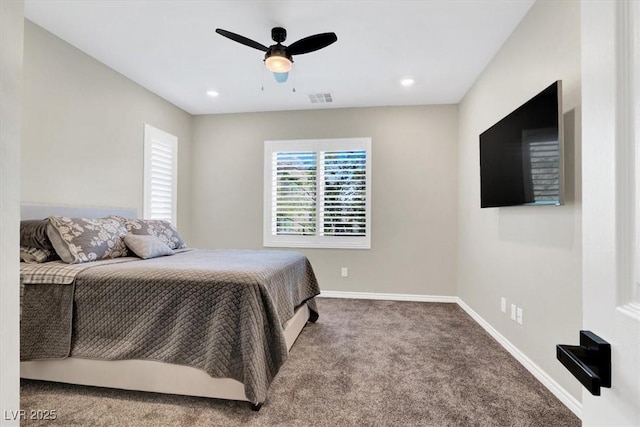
216, 27, 338, 83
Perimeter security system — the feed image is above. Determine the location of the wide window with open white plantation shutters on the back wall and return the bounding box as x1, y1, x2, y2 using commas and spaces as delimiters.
264, 138, 371, 249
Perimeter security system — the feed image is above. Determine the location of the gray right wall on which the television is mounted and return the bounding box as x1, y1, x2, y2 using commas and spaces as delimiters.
458, 2, 582, 400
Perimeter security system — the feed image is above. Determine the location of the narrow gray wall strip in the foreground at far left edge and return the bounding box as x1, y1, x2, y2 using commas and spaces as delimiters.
0, 1, 24, 425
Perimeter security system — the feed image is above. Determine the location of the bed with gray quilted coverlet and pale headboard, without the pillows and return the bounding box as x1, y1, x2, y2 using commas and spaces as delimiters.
20, 205, 319, 410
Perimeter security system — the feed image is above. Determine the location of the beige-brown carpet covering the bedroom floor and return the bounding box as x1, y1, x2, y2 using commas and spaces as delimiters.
21, 299, 580, 427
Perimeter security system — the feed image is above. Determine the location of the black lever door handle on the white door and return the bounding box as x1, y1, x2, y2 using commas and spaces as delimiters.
556, 331, 611, 396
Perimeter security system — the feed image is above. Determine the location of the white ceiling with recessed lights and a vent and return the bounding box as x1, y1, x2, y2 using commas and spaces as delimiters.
25, 0, 534, 114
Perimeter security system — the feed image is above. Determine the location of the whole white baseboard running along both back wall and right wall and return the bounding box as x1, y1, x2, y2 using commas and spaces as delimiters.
320, 291, 582, 419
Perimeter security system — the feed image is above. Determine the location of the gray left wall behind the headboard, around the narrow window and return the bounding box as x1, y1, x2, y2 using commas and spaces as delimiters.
22, 20, 191, 241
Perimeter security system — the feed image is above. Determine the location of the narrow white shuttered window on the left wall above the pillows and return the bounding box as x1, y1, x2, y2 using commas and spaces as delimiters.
143, 124, 178, 224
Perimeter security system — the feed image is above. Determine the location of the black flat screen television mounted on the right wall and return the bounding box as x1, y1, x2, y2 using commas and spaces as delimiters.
480, 80, 564, 208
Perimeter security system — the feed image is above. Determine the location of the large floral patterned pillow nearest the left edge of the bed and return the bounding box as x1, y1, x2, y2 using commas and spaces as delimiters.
47, 216, 128, 264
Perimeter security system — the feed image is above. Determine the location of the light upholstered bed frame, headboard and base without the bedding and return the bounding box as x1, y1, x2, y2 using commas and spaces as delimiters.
20, 205, 310, 411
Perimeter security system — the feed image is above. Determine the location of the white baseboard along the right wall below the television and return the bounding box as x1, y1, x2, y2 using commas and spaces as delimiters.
458, 298, 582, 419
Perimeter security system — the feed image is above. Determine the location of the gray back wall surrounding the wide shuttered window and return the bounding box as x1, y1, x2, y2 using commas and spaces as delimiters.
192, 106, 458, 296
